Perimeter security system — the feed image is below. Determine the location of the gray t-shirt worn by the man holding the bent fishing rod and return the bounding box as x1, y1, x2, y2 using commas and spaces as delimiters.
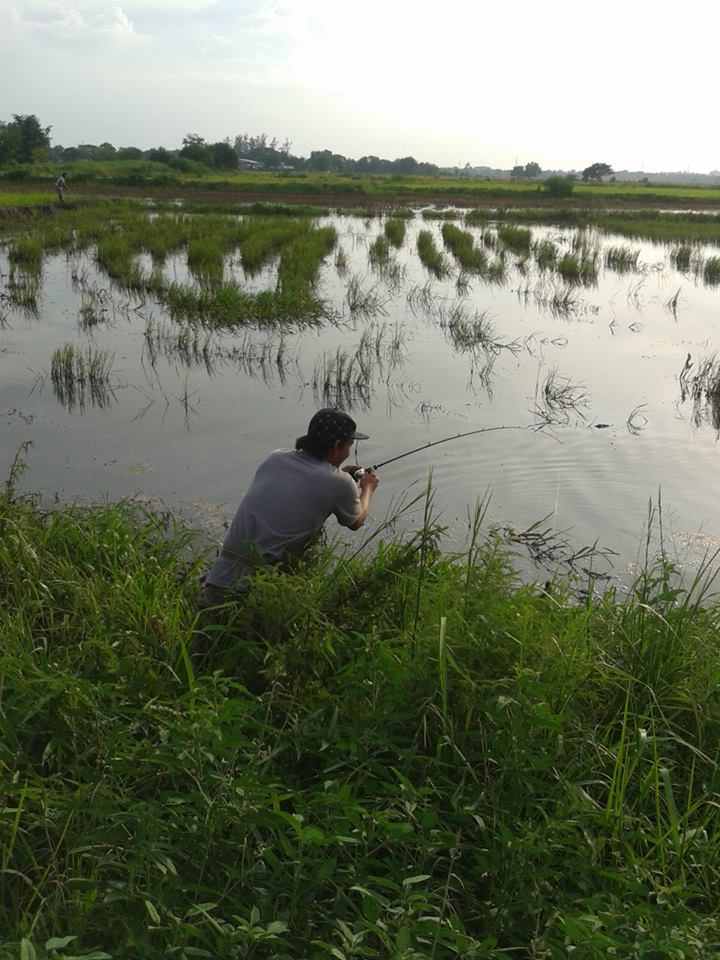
206, 450, 360, 590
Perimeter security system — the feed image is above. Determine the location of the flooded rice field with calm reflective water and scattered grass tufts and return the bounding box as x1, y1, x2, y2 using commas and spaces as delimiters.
0, 207, 720, 579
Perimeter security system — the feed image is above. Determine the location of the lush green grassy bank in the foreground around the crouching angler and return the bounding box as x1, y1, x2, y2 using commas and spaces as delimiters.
0, 464, 720, 960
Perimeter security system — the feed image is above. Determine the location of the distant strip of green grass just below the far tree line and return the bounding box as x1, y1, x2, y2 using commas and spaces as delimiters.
0, 161, 720, 207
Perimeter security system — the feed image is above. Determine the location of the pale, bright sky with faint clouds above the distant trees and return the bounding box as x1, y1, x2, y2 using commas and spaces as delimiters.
0, 0, 720, 173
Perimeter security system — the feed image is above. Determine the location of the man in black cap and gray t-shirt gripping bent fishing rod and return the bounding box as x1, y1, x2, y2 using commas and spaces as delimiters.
198, 408, 380, 608
